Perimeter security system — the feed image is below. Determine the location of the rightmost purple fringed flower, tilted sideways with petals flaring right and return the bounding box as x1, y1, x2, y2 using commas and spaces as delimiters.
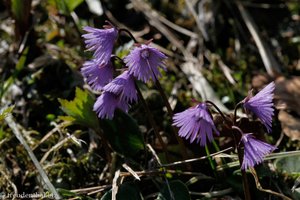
243, 82, 275, 133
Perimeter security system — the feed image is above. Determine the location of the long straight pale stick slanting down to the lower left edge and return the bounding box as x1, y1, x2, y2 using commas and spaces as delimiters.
5, 114, 61, 199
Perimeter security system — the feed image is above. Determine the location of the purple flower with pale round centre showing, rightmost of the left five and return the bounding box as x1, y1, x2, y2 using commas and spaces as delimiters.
124, 44, 167, 83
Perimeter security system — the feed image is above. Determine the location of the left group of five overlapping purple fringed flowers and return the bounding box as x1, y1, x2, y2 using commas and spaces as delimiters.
81, 25, 166, 119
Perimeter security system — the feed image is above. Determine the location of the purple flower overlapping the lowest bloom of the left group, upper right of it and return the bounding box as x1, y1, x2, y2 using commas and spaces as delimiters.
103, 71, 137, 102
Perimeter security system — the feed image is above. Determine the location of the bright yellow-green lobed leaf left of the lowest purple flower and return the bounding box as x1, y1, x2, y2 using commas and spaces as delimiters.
58, 88, 98, 129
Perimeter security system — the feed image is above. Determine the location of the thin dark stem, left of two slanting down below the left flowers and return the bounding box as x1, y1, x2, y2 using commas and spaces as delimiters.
135, 82, 169, 162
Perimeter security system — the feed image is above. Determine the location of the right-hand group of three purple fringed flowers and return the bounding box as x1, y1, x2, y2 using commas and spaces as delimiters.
173, 82, 276, 170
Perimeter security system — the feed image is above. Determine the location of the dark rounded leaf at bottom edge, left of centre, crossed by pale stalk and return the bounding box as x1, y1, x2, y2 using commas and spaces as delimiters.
101, 183, 142, 200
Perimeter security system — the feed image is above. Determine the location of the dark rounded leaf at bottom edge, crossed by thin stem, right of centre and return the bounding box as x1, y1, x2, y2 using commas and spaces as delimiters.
157, 180, 191, 200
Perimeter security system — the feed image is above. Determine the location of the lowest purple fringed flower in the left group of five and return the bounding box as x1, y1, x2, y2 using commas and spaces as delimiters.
93, 92, 129, 119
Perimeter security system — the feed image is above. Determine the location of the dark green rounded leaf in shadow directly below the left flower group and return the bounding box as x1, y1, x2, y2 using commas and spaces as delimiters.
100, 110, 144, 157
